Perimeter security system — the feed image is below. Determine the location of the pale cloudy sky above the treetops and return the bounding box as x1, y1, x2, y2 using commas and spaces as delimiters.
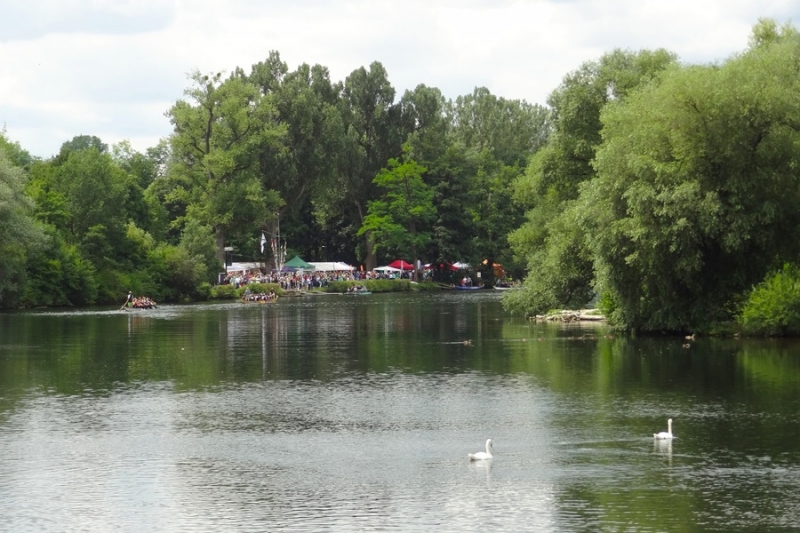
0, 0, 800, 158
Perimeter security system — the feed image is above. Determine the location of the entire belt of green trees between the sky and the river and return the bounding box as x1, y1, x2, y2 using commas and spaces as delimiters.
7, 19, 800, 331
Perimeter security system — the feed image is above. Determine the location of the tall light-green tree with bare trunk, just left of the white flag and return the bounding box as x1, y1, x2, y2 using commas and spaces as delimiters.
167, 72, 280, 265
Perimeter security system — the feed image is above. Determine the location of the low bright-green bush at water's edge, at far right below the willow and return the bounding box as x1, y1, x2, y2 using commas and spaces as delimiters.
738, 264, 800, 336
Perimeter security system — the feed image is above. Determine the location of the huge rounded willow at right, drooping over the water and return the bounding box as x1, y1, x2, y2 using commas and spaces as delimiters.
581, 25, 800, 330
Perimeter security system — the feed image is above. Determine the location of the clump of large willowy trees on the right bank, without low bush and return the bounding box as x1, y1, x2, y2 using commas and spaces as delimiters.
507, 21, 800, 331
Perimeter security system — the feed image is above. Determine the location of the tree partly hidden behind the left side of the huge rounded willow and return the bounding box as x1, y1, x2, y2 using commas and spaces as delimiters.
505, 50, 675, 314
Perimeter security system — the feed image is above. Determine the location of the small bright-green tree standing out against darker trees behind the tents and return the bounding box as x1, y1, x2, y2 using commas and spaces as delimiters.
358, 148, 436, 279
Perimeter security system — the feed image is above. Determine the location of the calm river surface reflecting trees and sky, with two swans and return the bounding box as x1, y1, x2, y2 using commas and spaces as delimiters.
0, 291, 800, 532
